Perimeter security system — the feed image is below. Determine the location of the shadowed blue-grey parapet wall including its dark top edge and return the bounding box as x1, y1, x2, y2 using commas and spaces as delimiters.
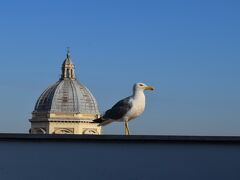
0, 134, 240, 180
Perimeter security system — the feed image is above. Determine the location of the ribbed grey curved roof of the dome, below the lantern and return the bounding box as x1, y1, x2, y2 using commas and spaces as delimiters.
34, 79, 99, 114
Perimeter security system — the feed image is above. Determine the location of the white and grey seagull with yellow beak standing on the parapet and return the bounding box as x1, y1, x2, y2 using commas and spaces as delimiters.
93, 83, 154, 135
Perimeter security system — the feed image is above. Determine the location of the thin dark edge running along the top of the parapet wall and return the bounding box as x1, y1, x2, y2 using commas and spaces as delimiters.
0, 133, 240, 144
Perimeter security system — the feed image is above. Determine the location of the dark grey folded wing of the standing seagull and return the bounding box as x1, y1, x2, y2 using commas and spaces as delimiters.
103, 97, 132, 120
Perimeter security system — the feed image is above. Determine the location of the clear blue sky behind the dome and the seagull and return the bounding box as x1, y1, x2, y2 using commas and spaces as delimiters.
0, 0, 240, 135
